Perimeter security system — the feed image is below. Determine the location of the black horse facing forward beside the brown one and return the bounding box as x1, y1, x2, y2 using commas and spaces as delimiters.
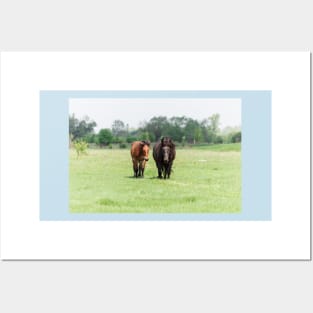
153, 137, 176, 179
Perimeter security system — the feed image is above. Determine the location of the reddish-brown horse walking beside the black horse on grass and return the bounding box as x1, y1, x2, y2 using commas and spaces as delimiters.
130, 140, 150, 177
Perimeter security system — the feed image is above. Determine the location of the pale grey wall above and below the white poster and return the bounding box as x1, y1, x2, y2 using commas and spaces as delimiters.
0, 0, 313, 313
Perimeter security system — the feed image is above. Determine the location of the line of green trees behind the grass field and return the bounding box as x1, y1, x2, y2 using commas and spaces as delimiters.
69, 114, 241, 148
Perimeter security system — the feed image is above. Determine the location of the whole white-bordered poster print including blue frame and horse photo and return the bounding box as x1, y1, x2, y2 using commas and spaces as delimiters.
1, 53, 309, 259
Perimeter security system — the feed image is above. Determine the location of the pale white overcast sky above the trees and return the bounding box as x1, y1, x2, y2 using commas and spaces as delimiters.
69, 99, 241, 132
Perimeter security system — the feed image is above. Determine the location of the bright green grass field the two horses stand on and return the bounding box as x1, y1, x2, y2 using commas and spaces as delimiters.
69, 144, 241, 213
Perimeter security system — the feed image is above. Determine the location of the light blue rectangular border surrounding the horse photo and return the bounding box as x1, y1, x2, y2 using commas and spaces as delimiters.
40, 90, 272, 221
